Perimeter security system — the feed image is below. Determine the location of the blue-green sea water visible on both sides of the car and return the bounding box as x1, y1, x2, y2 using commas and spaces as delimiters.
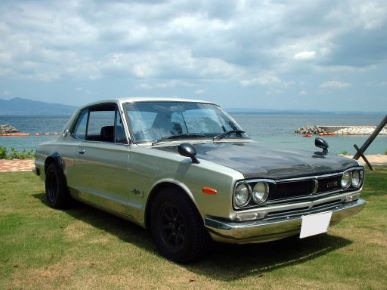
0, 113, 387, 154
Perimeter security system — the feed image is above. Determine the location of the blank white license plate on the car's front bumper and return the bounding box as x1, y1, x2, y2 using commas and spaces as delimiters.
300, 211, 332, 239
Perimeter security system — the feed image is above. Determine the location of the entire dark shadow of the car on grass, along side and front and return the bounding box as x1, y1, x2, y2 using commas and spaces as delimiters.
33, 193, 352, 281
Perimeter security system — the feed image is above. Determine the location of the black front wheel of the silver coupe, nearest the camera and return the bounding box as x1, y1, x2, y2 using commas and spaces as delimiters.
151, 189, 210, 263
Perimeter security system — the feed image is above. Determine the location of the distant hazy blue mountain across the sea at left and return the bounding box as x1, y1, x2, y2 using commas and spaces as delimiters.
0, 98, 75, 115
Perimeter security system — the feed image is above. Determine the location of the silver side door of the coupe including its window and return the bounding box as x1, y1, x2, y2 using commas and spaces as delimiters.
73, 104, 136, 215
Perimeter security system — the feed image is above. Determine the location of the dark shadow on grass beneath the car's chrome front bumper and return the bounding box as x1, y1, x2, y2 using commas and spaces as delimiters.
187, 234, 352, 281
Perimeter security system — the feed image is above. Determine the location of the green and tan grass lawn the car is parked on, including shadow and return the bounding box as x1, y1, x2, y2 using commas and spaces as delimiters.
0, 167, 387, 289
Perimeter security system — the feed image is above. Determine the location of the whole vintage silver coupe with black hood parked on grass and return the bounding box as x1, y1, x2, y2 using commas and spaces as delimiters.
35, 98, 366, 263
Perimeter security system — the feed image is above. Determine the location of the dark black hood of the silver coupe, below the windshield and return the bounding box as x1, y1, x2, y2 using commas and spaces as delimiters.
154, 142, 358, 179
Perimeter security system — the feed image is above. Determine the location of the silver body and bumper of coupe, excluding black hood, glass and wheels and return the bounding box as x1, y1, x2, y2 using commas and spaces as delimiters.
35, 98, 365, 243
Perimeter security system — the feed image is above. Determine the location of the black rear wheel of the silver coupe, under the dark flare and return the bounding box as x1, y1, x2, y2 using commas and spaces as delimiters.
45, 163, 70, 208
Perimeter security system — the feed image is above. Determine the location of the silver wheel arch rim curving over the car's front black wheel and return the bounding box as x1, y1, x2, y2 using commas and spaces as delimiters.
144, 179, 200, 229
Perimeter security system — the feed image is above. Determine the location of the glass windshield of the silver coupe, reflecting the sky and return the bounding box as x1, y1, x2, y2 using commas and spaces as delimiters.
124, 101, 247, 143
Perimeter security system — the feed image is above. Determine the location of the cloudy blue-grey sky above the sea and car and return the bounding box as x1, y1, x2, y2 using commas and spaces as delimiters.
0, 0, 387, 111
